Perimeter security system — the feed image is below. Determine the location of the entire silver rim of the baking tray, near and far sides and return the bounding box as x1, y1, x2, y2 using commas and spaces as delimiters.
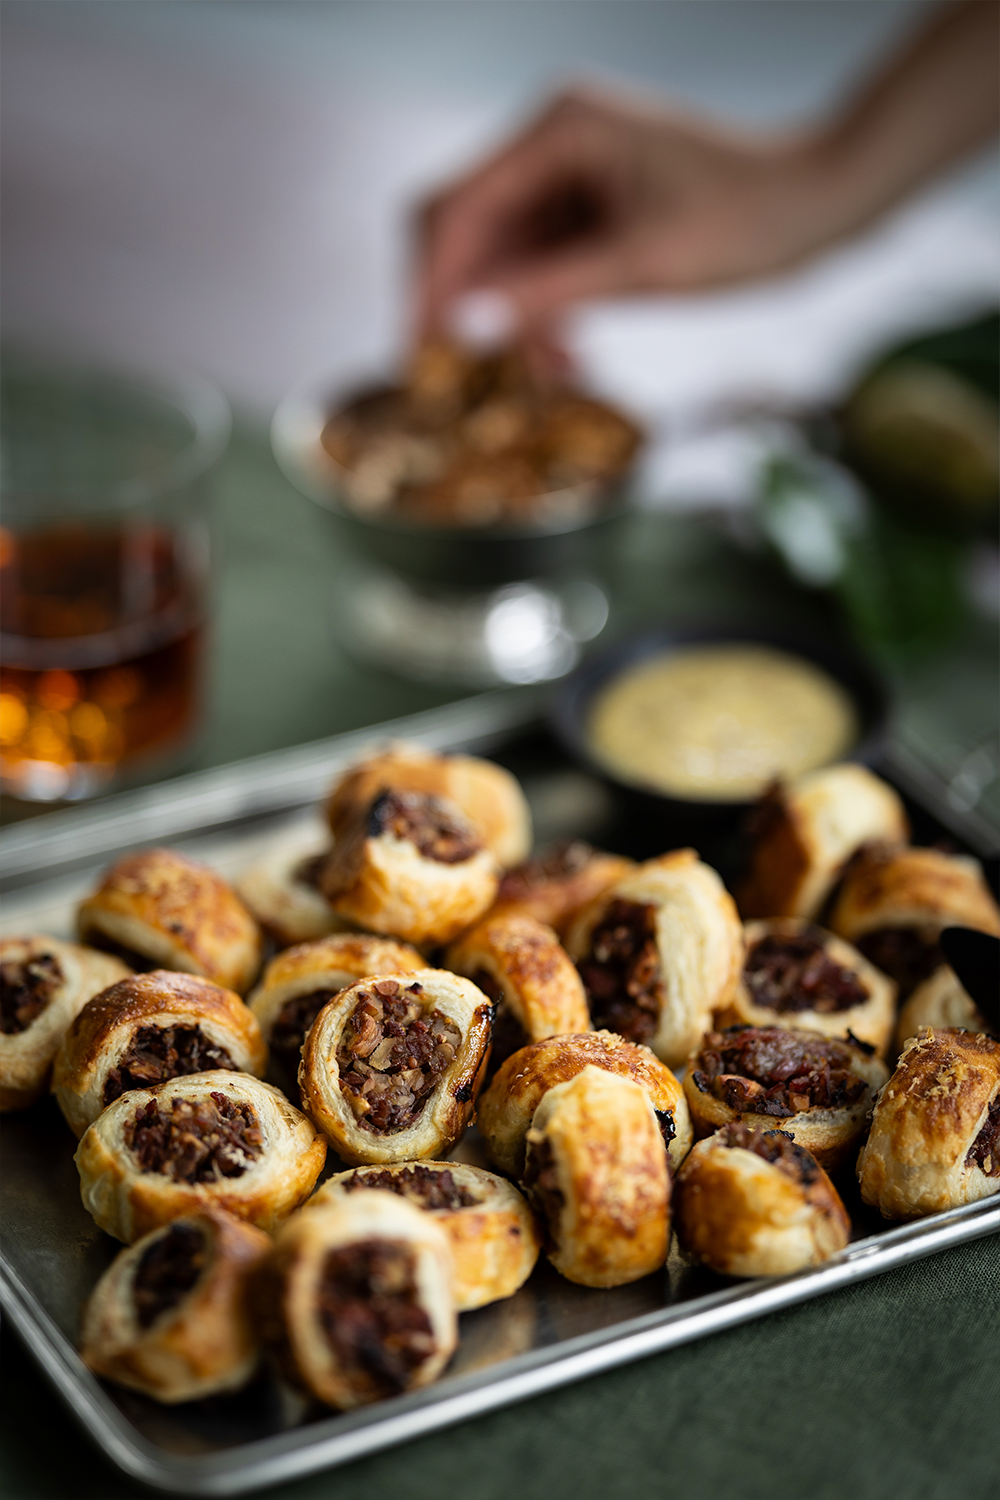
0, 689, 1000, 1496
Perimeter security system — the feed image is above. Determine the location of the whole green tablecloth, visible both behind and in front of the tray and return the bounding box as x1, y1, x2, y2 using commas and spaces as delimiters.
1, 431, 1000, 1500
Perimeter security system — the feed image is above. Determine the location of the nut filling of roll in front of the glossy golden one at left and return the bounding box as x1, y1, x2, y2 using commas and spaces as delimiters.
124, 1092, 264, 1182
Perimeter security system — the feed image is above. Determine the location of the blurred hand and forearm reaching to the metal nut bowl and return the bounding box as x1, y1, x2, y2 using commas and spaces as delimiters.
417, 0, 1000, 347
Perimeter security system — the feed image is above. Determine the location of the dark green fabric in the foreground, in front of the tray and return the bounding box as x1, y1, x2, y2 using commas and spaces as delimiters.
0, 1239, 1000, 1500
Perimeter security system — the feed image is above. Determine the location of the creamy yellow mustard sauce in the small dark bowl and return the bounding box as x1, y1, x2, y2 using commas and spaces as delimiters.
588, 645, 858, 801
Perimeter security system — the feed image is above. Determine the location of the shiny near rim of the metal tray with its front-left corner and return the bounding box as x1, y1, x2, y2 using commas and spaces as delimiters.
0, 1196, 1000, 1496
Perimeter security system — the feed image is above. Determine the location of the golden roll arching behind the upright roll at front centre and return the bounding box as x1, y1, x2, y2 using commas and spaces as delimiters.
477, 1032, 694, 1178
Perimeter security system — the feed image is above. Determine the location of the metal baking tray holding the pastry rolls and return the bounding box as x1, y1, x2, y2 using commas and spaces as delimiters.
0, 693, 1000, 1496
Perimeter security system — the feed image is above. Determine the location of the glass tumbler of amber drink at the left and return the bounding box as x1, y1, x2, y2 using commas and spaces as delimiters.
0, 362, 229, 801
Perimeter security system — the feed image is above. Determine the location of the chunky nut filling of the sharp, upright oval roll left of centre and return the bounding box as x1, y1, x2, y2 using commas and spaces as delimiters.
337, 980, 462, 1136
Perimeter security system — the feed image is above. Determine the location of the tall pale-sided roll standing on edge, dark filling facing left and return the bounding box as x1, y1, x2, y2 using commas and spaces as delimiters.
567, 849, 744, 1068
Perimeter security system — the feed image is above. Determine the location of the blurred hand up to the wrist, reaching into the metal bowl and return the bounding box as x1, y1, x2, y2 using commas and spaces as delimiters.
418, 89, 829, 342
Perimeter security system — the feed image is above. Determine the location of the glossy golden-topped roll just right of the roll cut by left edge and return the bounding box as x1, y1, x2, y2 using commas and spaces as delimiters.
52, 969, 267, 1136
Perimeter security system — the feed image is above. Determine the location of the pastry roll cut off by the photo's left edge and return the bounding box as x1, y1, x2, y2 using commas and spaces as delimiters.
0, 935, 129, 1112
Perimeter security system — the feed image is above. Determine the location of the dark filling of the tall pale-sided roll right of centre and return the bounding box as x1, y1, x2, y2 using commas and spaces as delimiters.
577, 900, 663, 1041
